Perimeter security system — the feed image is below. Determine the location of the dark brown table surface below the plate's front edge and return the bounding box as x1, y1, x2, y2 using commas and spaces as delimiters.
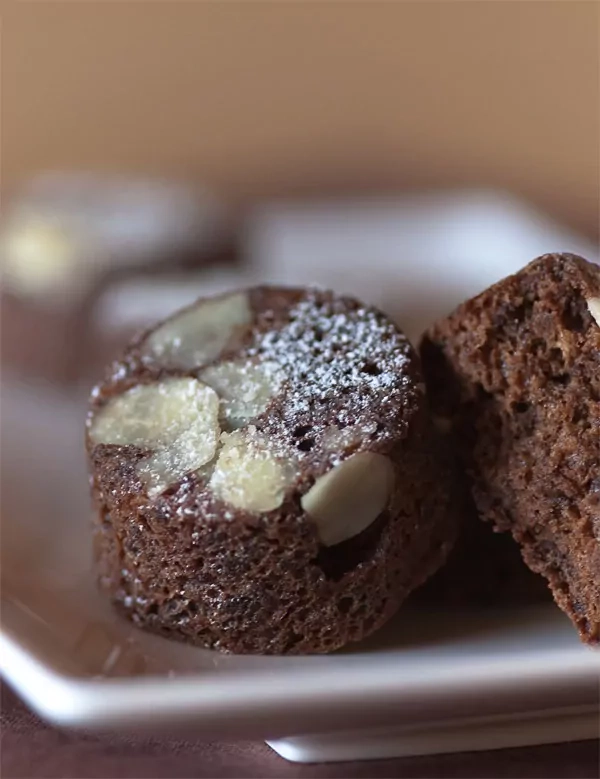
0, 686, 600, 779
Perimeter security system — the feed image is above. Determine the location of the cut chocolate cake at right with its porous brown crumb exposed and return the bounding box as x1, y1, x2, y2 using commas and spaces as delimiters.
422, 254, 600, 643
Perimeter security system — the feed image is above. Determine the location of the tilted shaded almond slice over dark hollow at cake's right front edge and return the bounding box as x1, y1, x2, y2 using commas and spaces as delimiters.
300, 452, 394, 546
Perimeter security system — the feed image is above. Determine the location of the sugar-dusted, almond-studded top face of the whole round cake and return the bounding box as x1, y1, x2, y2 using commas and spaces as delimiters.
88, 287, 423, 510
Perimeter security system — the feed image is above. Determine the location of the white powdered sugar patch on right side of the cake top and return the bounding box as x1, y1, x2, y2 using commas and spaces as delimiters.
248, 292, 418, 457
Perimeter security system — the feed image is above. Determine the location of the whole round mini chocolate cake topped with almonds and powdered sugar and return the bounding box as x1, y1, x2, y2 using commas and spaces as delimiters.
87, 287, 456, 653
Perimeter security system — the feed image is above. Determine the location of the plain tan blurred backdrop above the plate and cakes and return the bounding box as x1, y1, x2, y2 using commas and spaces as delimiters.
2, 0, 600, 238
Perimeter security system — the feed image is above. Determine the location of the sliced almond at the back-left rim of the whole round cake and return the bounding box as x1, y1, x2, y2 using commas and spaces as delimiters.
144, 292, 252, 369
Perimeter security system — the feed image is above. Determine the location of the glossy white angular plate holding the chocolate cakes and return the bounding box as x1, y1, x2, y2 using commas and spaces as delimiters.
0, 192, 600, 761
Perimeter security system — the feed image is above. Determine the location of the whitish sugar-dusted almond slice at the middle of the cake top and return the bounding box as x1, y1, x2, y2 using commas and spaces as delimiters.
200, 362, 284, 429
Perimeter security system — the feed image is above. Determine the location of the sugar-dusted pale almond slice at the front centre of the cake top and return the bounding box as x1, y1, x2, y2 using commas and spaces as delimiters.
209, 427, 293, 512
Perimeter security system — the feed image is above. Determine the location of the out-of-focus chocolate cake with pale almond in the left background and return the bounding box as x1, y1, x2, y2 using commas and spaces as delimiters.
0, 172, 238, 384
